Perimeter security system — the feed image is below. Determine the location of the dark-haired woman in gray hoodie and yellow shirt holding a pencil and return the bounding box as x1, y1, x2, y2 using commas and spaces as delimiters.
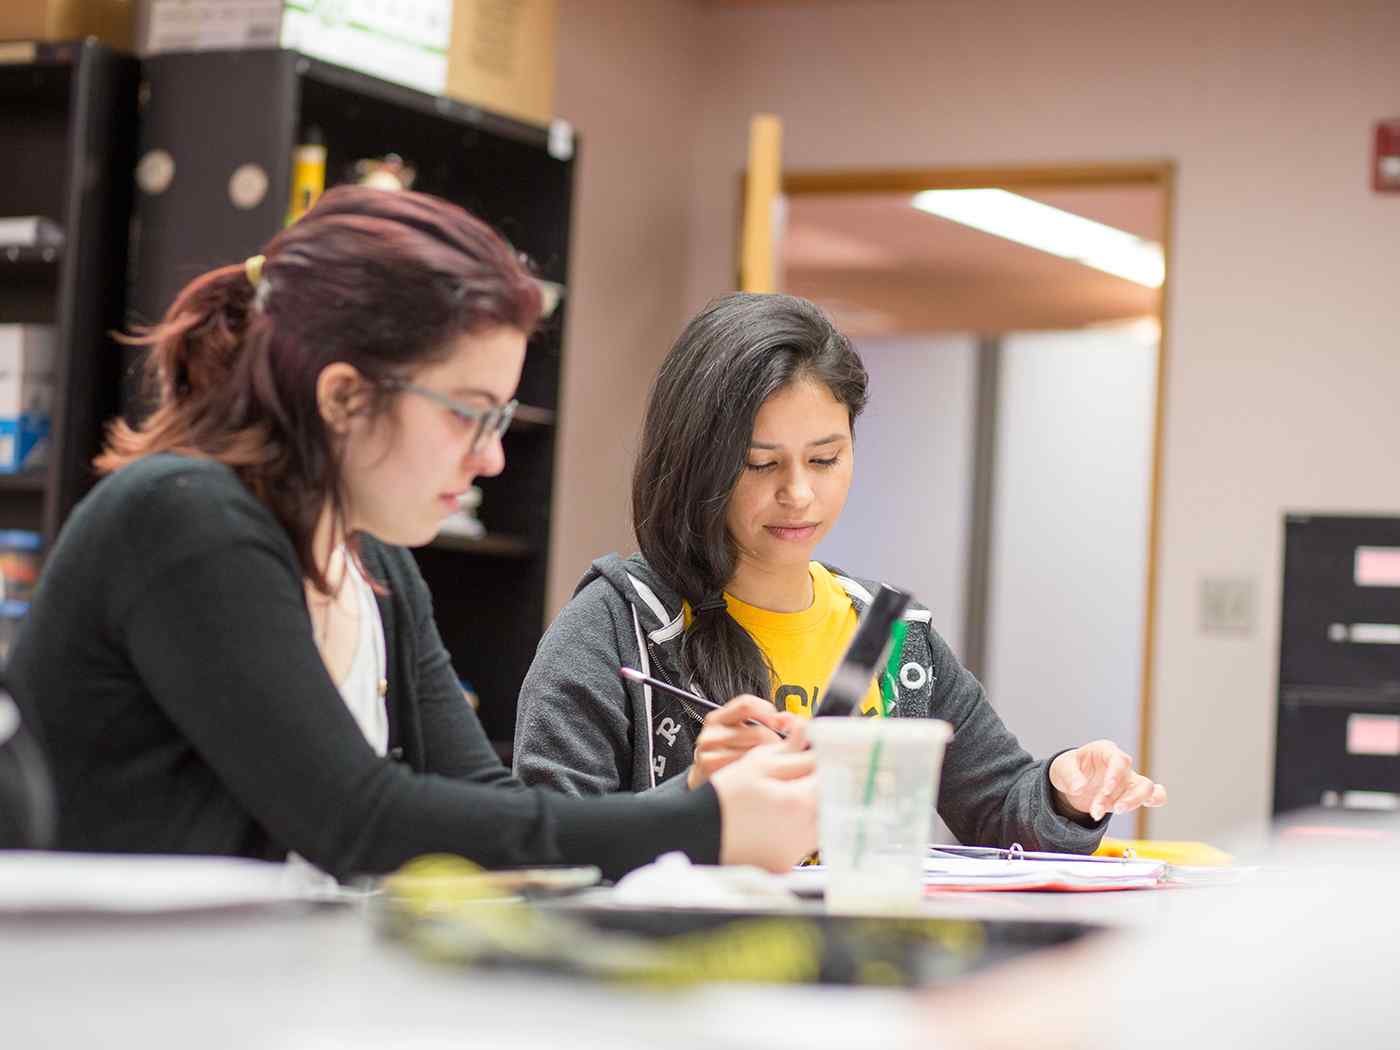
515, 294, 1166, 853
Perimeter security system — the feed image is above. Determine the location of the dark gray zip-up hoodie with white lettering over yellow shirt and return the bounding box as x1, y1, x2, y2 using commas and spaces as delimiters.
515, 554, 1107, 853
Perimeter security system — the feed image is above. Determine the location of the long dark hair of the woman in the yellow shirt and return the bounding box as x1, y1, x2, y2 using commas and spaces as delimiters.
631, 294, 868, 703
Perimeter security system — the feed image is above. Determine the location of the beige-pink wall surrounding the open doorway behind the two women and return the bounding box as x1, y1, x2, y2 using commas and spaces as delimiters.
554, 0, 1400, 837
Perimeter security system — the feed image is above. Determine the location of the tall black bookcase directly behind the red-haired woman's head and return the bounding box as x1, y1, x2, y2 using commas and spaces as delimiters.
126, 50, 574, 753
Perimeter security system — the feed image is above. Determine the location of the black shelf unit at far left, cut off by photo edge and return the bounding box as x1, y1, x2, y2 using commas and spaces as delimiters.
0, 41, 137, 545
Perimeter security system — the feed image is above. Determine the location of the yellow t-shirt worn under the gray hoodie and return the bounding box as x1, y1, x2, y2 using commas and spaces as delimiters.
685, 561, 882, 717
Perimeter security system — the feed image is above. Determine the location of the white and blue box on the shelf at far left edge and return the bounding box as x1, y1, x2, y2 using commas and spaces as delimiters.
0, 325, 57, 475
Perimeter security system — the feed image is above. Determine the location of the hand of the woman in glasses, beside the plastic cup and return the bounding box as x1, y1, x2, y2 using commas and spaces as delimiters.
713, 722, 816, 874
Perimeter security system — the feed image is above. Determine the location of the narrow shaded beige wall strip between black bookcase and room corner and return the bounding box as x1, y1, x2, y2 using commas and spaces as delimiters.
549, 0, 704, 616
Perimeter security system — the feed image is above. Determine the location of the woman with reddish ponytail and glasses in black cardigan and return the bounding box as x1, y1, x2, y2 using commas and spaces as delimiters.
7, 188, 816, 876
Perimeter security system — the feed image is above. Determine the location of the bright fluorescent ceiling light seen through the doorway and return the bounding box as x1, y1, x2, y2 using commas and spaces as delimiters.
913, 189, 1166, 288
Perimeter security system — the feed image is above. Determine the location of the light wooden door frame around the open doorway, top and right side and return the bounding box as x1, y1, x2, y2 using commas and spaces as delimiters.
780, 160, 1176, 839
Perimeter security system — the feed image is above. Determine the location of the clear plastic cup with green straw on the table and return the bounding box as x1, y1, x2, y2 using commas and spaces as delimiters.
806, 718, 952, 914
